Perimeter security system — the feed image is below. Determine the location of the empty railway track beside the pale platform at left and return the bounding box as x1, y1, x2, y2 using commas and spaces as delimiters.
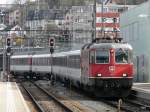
21, 82, 73, 112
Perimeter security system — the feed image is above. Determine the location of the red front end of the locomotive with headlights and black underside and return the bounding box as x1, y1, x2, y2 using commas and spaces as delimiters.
82, 43, 133, 97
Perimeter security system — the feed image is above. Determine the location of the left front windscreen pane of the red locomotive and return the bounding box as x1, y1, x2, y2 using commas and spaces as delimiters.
96, 49, 109, 64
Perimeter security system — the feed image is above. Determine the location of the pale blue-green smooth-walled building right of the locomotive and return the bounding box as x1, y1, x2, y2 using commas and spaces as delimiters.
120, 1, 150, 82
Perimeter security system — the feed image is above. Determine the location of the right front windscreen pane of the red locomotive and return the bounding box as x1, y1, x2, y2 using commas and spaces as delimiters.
115, 48, 129, 63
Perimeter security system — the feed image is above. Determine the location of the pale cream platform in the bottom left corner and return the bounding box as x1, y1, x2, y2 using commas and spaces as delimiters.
0, 82, 30, 112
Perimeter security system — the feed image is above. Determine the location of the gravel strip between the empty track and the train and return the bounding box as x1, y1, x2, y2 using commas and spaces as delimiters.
36, 81, 116, 112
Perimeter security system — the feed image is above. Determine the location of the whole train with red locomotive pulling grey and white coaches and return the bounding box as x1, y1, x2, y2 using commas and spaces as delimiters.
10, 39, 133, 97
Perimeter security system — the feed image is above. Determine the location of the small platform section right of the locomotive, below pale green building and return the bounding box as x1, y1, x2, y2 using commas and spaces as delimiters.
132, 83, 150, 100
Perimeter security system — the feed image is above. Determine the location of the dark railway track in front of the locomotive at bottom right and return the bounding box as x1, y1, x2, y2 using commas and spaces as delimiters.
102, 93, 150, 112
